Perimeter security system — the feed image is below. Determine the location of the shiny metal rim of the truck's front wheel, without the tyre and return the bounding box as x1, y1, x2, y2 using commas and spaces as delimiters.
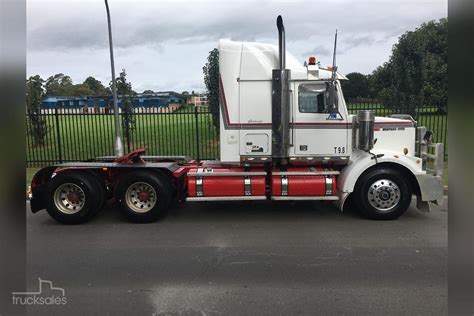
367, 179, 401, 212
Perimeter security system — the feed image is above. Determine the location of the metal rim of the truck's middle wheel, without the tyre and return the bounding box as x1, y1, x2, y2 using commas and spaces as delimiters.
125, 182, 157, 213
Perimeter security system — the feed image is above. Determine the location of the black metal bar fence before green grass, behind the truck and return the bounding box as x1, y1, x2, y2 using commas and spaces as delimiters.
26, 100, 447, 167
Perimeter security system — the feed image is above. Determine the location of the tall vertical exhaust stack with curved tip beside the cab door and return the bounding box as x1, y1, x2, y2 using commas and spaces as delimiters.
272, 15, 291, 165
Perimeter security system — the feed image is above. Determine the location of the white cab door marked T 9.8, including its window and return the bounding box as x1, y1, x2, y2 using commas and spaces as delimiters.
291, 81, 351, 157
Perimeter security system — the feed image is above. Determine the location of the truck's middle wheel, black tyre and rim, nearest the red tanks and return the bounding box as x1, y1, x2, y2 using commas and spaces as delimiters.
117, 171, 172, 223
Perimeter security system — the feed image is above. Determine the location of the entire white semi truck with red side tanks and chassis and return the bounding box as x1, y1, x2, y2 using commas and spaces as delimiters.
31, 16, 444, 224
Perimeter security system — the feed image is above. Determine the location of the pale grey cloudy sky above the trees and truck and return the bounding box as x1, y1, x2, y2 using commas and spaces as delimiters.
27, 0, 447, 92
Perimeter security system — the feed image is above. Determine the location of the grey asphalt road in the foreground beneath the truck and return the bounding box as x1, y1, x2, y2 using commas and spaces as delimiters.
27, 201, 448, 315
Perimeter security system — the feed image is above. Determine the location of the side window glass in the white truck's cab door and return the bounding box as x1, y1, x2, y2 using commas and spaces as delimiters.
298, 84, 328, 113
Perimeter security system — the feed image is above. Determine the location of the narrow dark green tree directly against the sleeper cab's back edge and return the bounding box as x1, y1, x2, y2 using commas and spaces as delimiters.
202, 48, 219, 131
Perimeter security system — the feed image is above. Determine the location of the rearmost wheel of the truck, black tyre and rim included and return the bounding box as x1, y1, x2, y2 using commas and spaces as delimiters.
46, 172, 105, 224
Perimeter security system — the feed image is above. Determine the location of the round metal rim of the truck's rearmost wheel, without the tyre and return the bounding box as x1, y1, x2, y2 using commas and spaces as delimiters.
53, 183, 86, 214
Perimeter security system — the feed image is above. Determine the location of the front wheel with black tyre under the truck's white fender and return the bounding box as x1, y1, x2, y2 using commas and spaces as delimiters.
354, 168, 412, 220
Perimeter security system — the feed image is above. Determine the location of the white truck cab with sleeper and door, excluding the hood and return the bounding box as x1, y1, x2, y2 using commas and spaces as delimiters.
219, 40, 352, 163
